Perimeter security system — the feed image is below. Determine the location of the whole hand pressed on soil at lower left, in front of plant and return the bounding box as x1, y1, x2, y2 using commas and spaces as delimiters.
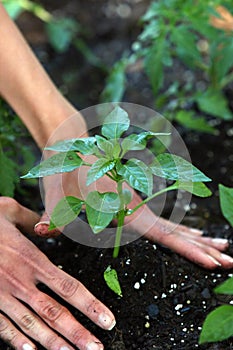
0, 197, 115, 350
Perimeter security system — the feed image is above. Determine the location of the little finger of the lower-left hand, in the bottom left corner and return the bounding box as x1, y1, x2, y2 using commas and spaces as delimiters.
0, 313, 36, 350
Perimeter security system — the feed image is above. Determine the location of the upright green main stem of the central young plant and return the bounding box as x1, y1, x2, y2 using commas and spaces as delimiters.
112, 181, 125, 258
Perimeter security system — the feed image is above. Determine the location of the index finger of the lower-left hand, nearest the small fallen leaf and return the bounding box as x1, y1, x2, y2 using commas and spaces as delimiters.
39, 266, 116, 330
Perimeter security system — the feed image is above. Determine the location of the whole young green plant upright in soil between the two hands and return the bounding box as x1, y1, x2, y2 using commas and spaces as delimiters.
23, 106, 211, 258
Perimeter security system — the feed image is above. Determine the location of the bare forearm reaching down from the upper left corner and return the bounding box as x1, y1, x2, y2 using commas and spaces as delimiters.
0, 4, 86, 148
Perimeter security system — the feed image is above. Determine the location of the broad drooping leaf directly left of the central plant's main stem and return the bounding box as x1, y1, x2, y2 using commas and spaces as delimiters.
85, 191, 120, 233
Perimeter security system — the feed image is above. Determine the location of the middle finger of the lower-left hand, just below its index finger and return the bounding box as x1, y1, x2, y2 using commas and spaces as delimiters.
29, 291, 103, 350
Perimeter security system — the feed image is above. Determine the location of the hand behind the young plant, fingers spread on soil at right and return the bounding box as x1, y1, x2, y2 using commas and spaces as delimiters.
36, 168, 233, 269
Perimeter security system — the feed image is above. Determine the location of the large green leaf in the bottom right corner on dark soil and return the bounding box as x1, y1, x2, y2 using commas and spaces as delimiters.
199, 305, 233, 344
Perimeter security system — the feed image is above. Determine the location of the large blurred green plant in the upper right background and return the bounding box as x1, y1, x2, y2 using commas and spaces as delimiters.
102, 0, 233, 134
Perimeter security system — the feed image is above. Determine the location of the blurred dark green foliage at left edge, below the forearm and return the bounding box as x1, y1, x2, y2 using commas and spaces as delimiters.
0, 99, 35, 197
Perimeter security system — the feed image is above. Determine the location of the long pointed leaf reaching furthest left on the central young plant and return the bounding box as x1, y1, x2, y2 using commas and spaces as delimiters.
21, 151, 83, 179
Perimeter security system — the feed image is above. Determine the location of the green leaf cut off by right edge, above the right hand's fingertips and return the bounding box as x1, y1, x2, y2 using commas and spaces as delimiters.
219, 184, 233, 226
